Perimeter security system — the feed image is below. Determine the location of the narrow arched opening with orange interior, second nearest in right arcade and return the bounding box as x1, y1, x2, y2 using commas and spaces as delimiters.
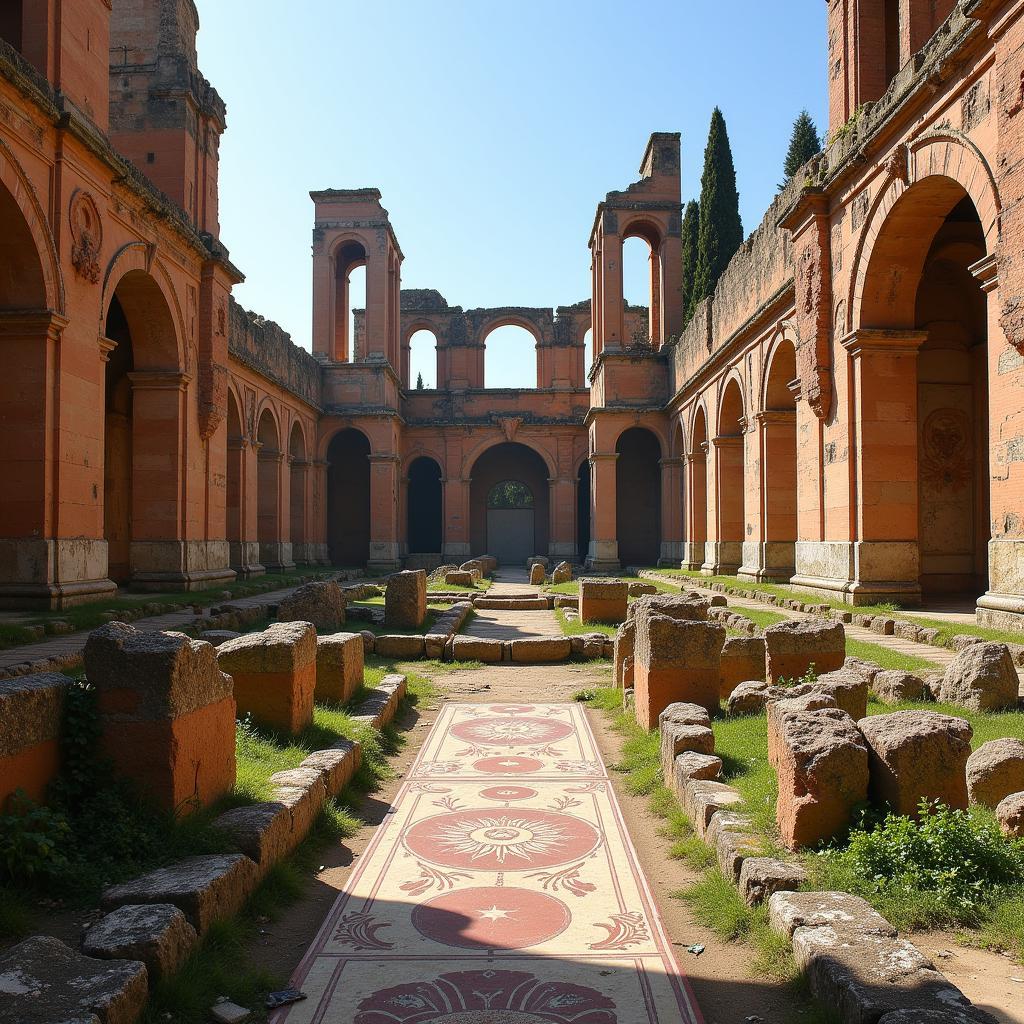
759, 338, 797, 580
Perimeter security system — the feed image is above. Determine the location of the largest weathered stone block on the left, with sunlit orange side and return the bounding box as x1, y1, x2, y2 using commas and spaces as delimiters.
85, 623, 240, 811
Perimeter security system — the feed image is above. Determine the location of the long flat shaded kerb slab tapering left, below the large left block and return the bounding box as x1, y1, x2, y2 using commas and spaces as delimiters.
101, 853, 259, 935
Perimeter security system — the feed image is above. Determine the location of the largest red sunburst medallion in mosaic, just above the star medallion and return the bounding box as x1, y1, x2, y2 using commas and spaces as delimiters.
404, 807, 601, 871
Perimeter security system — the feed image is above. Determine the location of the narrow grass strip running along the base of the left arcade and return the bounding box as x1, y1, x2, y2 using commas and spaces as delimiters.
0, 565, 337, 649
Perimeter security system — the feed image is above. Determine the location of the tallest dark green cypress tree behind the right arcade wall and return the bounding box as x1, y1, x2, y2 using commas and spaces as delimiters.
690, 106, 743, 308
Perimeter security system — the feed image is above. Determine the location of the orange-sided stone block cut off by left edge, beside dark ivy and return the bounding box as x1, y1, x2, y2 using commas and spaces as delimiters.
0, 673, 73, 813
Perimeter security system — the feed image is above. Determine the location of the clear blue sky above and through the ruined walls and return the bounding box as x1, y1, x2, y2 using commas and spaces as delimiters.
198, 0, 826, 386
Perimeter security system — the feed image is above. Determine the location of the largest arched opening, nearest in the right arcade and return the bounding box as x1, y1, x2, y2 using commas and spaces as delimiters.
852, 175, 997, 602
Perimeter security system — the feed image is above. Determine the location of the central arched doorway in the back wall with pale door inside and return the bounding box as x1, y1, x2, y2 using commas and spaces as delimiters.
470, 441, 550, 565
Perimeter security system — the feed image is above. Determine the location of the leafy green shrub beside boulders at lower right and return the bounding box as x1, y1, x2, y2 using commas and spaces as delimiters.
820, 801, 1024, 928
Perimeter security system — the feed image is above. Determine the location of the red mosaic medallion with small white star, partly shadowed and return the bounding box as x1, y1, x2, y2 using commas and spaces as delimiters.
413, 886, 571, 949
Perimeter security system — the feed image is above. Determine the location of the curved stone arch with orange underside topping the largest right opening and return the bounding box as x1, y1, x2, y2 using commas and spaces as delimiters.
847, 130, 1001, 330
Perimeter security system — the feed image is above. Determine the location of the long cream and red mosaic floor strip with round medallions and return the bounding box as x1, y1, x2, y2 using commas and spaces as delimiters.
271, 703, 701, 1024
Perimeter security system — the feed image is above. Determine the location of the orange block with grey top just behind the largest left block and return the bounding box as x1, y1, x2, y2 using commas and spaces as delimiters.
217, 623, 316, 733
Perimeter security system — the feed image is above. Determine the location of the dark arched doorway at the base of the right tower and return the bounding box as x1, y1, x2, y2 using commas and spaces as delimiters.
615, 427, 662, 566
